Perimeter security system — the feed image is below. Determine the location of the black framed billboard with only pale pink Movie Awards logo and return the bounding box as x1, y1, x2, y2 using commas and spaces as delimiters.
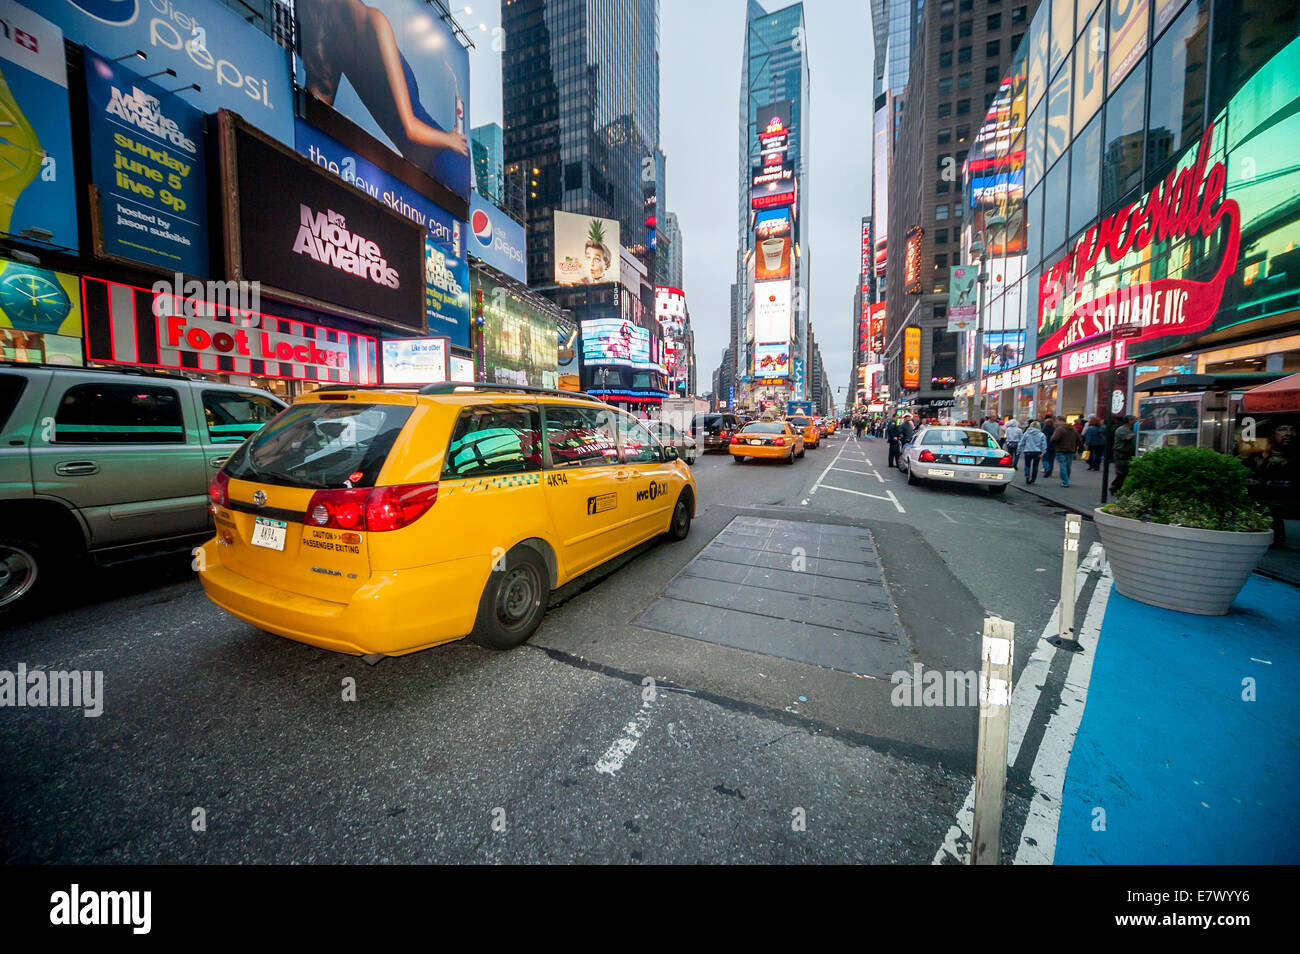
228, 123, 426, 331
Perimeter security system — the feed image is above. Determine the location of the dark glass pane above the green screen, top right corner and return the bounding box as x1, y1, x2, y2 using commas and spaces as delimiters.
1206, 0, 1300, 114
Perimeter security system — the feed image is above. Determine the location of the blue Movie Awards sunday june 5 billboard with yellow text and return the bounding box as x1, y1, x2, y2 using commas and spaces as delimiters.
85, 49, 211, 276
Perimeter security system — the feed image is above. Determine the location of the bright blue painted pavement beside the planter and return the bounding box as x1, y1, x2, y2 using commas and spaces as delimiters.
1056, 574, 1300, 864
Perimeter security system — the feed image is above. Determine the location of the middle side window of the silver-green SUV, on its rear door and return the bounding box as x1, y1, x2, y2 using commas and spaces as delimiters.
53, 383, 185, 445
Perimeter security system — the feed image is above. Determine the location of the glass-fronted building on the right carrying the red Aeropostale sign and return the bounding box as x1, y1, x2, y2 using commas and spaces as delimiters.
958, 0, 1300, 450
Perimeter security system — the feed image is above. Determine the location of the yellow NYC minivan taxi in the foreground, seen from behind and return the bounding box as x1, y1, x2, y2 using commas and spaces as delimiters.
196, 383, 696, 655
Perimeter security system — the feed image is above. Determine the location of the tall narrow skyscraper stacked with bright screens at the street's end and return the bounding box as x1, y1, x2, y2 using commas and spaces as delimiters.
736, 0, 810, 413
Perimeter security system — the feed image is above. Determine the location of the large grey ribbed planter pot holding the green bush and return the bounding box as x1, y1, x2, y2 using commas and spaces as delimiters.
1093, 507, 1273, 616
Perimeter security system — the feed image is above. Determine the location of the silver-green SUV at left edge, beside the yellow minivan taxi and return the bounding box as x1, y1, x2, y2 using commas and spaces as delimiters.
0, 361, 285, 613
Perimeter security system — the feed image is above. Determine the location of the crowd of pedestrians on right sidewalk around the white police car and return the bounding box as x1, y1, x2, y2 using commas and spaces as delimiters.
848, 409, 1138, 494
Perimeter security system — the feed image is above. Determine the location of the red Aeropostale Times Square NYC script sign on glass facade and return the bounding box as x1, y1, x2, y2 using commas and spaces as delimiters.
1039, 123, 1242, 354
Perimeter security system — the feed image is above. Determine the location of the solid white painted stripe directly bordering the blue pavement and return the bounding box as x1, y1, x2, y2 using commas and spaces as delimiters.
1015, 568, 1110, 864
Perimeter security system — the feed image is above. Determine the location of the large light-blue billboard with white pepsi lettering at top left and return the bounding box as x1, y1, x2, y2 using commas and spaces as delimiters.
45, 0, 292, 143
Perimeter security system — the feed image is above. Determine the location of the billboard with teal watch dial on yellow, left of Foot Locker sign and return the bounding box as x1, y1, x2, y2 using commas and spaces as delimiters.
0, 259, 82, 364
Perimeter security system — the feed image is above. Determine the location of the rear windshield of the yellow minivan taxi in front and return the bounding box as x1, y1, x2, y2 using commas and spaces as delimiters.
225, 403, 411, 490
